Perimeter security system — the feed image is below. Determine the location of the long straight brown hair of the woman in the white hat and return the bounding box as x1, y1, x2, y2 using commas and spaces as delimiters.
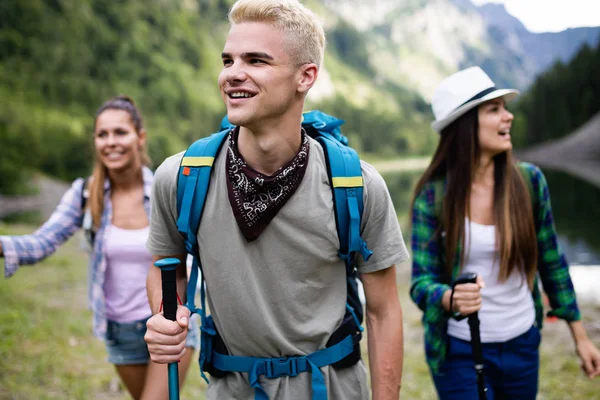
411, 107, 538, 288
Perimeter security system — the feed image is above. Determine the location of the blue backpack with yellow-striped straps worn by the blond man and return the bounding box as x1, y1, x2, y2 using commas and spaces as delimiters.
177, 111, 372, 400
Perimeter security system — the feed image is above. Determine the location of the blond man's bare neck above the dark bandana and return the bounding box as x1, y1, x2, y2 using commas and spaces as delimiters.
238, 115, 302, 175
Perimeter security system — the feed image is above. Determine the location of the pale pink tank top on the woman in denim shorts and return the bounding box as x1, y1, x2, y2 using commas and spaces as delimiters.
104, 224, 152, 323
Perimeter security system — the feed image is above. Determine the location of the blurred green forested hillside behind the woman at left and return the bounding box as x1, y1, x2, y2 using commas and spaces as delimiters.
0, 0, 241, 193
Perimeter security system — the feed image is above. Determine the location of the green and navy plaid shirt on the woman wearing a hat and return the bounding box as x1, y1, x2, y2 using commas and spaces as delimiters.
410, 163, 581, 373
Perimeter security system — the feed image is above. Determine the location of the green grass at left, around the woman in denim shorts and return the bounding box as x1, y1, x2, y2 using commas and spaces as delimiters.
0, 225, 206, 400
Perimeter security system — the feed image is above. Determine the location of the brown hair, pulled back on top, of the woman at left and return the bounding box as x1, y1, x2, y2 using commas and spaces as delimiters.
87, 96, 152, 229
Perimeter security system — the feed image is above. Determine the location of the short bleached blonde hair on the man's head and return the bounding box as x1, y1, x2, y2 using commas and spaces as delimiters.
229, 0, 325, 68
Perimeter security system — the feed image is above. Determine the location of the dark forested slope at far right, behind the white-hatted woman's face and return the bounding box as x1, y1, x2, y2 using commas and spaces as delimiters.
509, 42, 600, 147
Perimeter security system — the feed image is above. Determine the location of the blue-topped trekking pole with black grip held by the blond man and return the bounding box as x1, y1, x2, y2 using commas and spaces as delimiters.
154, 258, 180, 400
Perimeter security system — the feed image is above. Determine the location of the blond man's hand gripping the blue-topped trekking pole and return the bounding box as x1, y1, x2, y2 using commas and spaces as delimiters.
144, 305, 190, 364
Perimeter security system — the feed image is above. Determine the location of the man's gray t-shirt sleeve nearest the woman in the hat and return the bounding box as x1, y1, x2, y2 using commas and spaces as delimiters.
357, 161, 410, 273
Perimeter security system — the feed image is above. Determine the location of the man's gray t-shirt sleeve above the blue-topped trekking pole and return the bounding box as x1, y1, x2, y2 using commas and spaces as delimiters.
146, 152, 186, 256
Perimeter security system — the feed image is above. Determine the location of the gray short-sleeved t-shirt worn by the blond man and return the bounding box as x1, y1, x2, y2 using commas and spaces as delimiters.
147, 139, 409, 400
